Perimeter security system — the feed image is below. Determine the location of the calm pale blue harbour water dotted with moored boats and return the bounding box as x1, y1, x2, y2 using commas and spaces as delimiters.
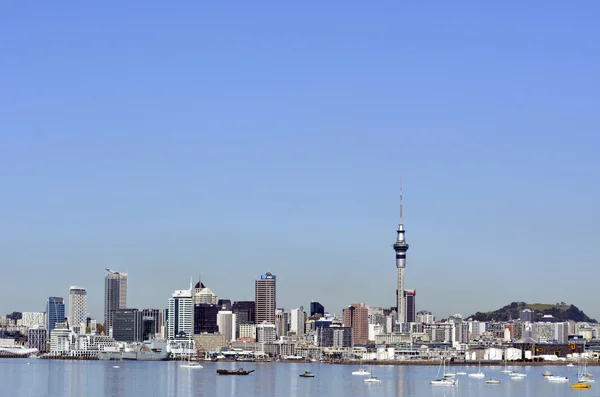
0, 359, 600, 397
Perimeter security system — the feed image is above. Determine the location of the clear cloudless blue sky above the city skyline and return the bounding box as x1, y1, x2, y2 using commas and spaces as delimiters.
0, 0, 600, 319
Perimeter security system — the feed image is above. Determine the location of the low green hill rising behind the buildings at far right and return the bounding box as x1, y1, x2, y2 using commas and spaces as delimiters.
467, 302, 596, 323
